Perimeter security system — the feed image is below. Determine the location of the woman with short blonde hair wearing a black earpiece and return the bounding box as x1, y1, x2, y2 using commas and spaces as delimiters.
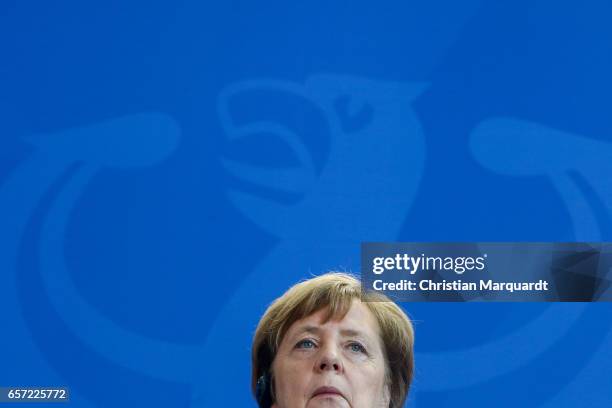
252, 273, 414, 408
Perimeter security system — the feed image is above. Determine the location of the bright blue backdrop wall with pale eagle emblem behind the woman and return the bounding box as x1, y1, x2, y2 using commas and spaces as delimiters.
0, 0, 612, 408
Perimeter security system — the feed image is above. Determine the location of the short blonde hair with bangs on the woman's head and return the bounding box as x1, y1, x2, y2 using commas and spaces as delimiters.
251, 272, 414, 408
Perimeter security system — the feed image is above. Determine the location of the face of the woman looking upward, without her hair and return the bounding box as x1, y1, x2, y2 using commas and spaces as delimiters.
272, 300, 389, 408
